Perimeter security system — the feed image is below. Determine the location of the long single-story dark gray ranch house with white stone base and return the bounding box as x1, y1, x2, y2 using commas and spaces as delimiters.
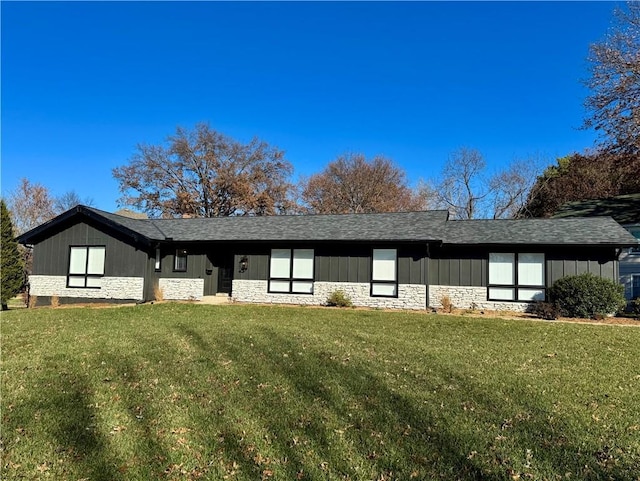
18, 206, 637, 310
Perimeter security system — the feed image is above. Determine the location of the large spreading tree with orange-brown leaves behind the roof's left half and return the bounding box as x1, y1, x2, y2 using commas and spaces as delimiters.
113, 123, 293, 217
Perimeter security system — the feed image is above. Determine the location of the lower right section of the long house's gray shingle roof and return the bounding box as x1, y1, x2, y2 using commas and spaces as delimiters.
443, 217, 636, 246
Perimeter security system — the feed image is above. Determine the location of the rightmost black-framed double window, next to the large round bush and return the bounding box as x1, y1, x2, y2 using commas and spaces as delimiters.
488, 252, 545, 302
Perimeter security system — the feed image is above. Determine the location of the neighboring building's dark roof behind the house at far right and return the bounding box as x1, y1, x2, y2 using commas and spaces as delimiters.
553, 193, 640, 225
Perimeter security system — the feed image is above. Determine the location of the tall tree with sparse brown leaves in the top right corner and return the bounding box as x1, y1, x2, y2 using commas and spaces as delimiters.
585, 2, 640, 154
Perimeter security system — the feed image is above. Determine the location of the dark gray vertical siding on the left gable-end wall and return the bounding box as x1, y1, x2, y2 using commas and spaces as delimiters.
32, 218, 148, 277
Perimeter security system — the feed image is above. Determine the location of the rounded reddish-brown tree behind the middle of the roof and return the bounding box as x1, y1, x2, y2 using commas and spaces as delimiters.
300, 154, 425, 214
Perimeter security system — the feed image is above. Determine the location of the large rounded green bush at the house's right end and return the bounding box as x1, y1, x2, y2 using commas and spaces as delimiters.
548, 273, 626, 318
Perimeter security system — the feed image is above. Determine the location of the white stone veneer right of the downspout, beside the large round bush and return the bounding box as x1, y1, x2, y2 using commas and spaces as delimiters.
429, 286, 531, 312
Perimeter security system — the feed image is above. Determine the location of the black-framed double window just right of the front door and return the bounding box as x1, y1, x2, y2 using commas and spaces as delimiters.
268, 249, 314, 294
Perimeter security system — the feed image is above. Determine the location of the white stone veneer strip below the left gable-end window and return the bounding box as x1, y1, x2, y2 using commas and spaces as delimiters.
29, 275, 144, 301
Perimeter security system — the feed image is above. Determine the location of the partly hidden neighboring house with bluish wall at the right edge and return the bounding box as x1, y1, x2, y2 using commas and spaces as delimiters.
553, 193, 640, 300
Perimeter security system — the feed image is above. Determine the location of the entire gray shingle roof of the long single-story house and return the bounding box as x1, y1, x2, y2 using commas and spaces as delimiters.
18, 206, 637, 246
